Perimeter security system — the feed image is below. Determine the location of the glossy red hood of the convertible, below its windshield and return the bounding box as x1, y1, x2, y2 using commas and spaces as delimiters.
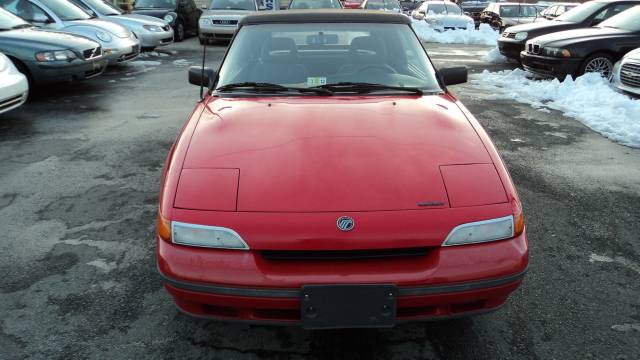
177, 96, 505, 212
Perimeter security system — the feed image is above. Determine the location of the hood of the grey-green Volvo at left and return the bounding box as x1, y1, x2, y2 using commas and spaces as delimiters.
1, 28, 100, 52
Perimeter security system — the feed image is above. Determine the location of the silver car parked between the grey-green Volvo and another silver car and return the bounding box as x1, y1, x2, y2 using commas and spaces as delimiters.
2, 0, 140, 65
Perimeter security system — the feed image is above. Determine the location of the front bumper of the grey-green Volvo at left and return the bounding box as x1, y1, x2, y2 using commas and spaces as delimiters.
29, 57, 108, 85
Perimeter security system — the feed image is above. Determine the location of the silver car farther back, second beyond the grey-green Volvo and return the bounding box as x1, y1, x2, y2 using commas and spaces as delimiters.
70, 0, 173, 50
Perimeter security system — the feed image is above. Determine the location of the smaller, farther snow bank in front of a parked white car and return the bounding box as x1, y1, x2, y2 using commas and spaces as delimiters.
412, 20, 500, 45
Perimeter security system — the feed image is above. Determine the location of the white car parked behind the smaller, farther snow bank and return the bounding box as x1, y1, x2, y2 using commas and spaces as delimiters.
411, 1, 475, 31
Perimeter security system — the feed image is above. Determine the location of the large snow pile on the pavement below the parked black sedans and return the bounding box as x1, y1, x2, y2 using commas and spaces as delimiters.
471, 69, 640, 148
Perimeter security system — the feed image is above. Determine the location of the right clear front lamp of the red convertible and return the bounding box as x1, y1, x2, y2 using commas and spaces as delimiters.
442, 215, 515, 246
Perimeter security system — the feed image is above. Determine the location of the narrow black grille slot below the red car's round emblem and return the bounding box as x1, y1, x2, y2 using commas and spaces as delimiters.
262, 247, 430, 261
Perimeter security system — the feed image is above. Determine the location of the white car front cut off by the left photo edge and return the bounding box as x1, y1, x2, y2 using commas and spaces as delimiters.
0, 53, 29, 114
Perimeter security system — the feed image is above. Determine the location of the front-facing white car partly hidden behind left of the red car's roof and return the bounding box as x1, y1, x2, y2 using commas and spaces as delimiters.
198, 0, 258, 44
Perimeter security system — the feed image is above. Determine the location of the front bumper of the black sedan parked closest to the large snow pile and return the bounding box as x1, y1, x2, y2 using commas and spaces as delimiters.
520, 51, 582, 80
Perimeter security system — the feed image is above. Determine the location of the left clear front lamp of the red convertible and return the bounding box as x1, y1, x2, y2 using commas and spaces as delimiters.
171, 221, 249, 250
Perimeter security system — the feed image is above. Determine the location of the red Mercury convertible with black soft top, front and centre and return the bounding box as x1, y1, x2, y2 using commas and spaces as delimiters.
156, 10, 528, 329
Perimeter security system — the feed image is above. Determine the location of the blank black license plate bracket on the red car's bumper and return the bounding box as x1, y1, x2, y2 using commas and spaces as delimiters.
300, 284, 398, 329
